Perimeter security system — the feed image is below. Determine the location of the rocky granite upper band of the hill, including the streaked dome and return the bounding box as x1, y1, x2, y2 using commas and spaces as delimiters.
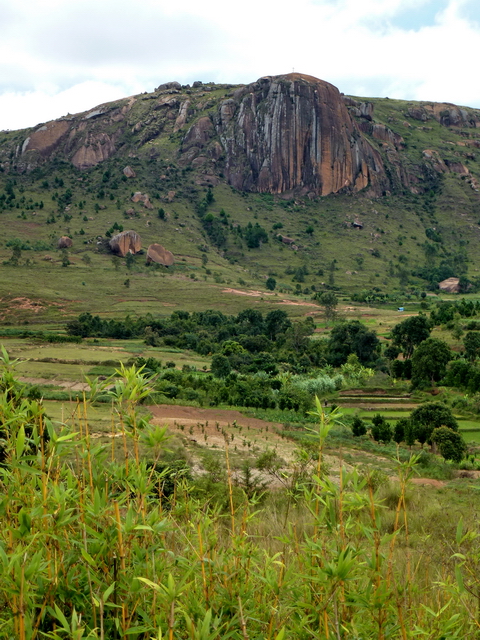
0, 73, 480, 197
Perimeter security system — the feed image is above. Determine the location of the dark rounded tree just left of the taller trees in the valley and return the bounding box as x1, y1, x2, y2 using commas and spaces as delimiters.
327, 320, 380, 367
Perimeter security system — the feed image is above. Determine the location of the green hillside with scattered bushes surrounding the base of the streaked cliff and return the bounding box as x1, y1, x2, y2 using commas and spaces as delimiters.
0, 80, 480, 321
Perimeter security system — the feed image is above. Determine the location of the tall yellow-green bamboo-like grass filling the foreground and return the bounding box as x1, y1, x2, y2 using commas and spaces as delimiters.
0, 361, 480, 640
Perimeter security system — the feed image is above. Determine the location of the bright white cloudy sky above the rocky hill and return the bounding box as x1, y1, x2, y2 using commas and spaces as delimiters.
0, 0, 480, 129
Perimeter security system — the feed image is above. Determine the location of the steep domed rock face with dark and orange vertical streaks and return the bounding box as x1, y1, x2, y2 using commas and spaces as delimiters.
214, 73, 384, 195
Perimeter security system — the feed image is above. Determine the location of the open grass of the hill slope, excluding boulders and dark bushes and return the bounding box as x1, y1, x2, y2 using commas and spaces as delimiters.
0, 88, 480, 322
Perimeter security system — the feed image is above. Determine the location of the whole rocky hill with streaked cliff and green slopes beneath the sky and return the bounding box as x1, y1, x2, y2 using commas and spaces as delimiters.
0, 73, 480, 322
